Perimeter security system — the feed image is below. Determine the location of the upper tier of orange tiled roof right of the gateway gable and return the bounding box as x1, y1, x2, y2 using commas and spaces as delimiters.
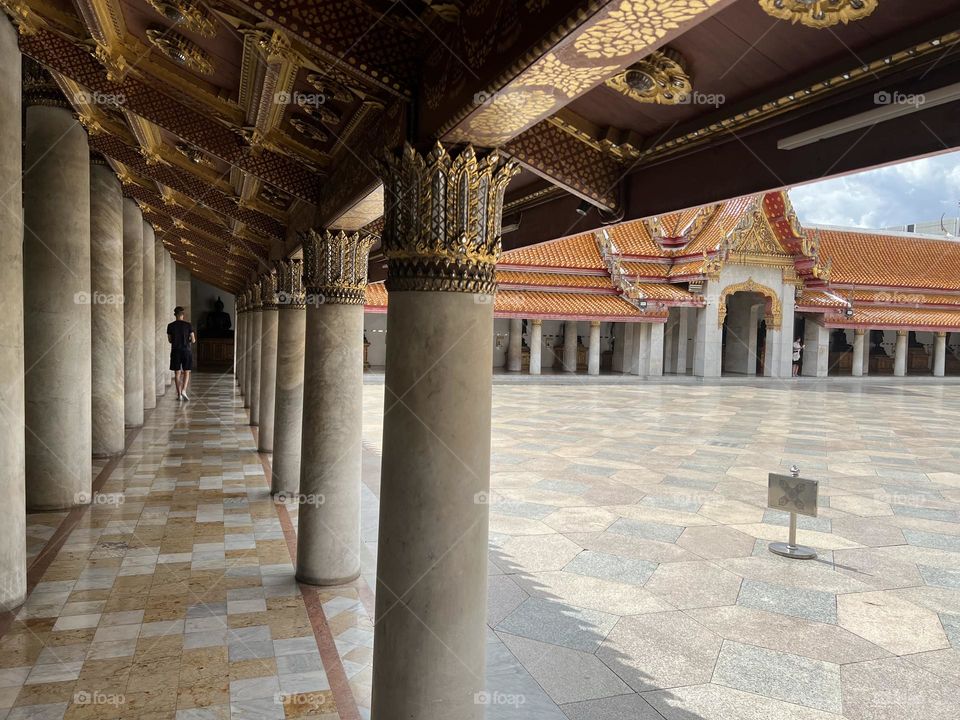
817, 228, 960, 290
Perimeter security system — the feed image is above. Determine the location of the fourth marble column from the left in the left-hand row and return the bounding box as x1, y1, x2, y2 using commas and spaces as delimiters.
123, 197, 143, 427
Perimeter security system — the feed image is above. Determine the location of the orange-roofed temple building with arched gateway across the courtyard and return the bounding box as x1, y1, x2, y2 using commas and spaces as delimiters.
366, 191, 960, 377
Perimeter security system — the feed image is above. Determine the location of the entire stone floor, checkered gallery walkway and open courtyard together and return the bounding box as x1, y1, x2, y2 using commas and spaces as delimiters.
0, 376, 960, 720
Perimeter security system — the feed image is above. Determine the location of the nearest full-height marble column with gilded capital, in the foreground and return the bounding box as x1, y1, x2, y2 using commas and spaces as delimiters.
371, 146, 516, 720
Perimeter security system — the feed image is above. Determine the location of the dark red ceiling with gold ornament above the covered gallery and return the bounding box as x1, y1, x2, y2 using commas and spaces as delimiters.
0, 0, 960, 292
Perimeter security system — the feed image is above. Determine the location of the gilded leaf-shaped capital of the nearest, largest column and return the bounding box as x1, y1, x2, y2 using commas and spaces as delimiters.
379, 143, 519, 294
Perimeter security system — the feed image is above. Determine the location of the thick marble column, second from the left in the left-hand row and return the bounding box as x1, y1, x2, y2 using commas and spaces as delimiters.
23, 60, 93, 510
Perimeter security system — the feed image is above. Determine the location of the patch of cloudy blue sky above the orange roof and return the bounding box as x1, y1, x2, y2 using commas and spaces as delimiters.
790, 152, 960, 228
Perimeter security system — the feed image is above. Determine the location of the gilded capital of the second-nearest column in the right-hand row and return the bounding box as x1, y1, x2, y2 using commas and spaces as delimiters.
302, 230, 375, 305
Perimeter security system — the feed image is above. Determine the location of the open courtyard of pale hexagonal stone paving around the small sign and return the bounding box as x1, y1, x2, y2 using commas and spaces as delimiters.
366, 378, 960, 720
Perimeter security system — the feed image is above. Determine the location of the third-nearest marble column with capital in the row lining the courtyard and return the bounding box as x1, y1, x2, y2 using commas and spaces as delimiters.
270, 260, 307, 495
